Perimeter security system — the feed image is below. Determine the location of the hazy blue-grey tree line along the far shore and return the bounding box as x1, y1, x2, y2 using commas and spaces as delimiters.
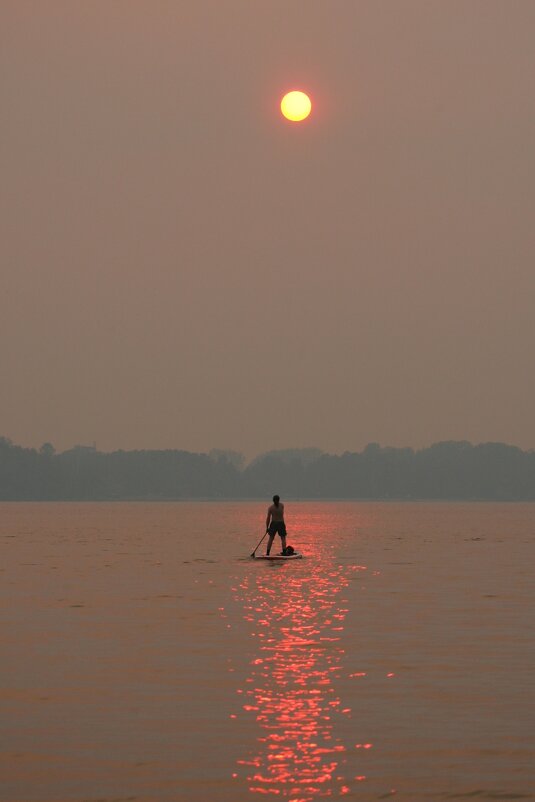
0, 438, 535, 501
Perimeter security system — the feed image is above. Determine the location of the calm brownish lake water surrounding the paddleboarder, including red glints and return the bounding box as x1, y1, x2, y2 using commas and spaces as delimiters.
0, 502, 535, 802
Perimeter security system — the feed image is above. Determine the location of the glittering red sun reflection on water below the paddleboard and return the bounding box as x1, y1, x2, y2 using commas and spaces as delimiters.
235, 538, 366, 802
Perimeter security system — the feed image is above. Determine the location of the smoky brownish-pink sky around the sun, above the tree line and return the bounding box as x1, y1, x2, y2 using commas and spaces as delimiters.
0, 0, 535, 455
